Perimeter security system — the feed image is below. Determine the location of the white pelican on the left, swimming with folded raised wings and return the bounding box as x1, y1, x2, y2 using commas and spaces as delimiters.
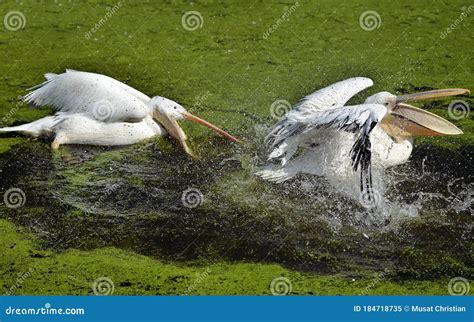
0, 69, 239, 155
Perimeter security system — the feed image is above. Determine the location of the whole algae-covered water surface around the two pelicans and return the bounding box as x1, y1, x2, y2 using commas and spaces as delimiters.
0, 1, 474, 294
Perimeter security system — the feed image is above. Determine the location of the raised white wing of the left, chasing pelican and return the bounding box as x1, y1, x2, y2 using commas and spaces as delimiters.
23, 70, 150, 123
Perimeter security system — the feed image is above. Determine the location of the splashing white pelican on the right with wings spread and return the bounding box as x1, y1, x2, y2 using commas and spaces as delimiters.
256, 77, 469, 205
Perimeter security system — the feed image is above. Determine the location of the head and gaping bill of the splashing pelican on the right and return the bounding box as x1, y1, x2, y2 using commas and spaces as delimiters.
365, 88, 469, 141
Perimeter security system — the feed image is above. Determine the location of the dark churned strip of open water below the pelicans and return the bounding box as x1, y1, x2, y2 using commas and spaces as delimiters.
0, 137, 474, 278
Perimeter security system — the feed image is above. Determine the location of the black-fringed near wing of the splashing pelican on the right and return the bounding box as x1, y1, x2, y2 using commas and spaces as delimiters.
269, 104, 387, 200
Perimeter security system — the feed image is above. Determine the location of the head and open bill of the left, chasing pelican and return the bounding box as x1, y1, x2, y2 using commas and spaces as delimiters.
150, 96, 240, 156
